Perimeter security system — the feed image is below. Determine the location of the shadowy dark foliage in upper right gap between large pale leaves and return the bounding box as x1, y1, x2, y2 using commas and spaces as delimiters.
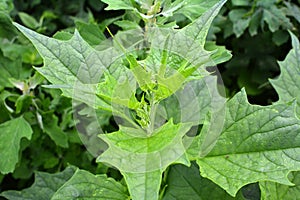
209, 0, 299, 99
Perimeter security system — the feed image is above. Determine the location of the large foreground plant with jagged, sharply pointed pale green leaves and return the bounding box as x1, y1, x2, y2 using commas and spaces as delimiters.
15, 0, 300, 199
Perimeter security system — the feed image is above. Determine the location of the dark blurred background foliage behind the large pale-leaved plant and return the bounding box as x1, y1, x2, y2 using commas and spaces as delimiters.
0, 0, 300, 199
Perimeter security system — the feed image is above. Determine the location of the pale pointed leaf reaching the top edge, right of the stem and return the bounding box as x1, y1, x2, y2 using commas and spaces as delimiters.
149, 0, 230, 71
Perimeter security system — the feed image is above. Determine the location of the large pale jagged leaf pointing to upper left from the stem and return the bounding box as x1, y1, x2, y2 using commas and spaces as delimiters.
15, 23, 118, 110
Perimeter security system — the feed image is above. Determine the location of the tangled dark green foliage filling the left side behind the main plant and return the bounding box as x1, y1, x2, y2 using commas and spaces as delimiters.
0, 0, 107, 191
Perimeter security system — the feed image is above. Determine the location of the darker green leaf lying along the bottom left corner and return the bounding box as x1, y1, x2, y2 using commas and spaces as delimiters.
0, 167, 76, 200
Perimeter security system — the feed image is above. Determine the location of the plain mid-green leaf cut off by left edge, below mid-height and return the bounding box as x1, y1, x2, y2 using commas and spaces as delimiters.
0, 117, 32, 174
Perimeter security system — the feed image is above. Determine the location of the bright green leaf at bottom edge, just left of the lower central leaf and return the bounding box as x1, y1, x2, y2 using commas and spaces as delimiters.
51, 169, 129, 200
